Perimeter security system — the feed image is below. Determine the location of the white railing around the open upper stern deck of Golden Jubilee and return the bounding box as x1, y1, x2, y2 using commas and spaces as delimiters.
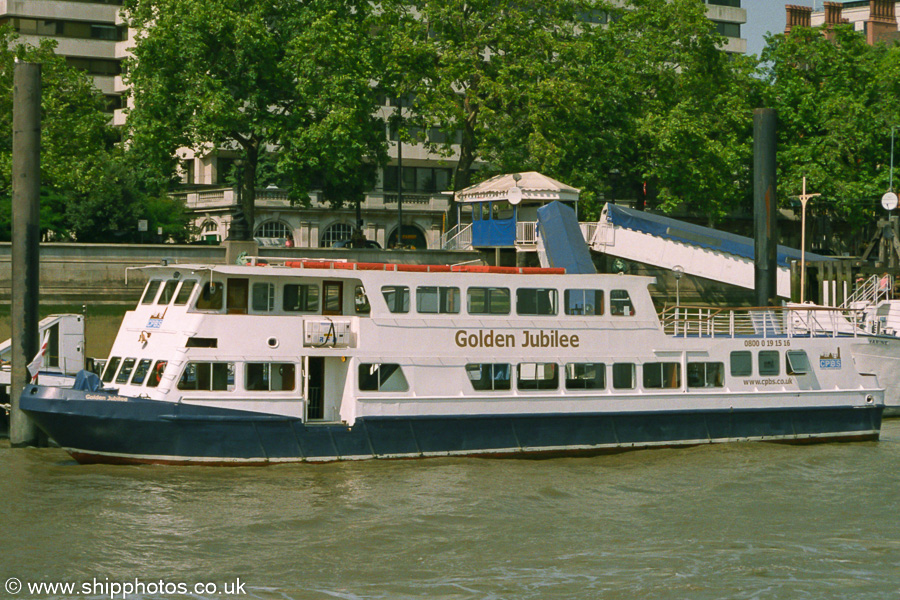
660, 306, 862, 339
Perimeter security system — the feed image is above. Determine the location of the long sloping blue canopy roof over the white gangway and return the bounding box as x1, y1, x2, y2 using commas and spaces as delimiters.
606, 203, 834, 267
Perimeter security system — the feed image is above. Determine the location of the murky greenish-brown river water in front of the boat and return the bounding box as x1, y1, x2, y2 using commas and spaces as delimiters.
0, 420, 900, 600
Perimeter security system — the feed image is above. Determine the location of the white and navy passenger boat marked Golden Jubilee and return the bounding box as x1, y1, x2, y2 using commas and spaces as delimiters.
20, 259, 884, 464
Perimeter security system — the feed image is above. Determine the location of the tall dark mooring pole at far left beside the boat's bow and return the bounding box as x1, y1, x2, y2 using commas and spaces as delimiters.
9, 61, 41, 446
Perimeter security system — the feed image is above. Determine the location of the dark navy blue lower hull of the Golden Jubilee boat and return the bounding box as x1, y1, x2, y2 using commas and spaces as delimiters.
20, 386, 883, 464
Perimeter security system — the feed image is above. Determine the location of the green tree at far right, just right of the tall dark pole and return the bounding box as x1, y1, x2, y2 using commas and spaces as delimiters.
762, 25, 900, 225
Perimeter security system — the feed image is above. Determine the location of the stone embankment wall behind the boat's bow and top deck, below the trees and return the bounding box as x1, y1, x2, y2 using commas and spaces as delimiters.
0, 243, 482, 305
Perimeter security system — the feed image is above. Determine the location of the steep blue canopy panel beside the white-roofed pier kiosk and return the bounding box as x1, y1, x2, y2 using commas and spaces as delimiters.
538, 201, 597, 274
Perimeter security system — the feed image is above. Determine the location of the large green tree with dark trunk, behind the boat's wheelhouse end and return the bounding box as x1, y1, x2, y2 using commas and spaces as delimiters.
125, 0, 386, 237
